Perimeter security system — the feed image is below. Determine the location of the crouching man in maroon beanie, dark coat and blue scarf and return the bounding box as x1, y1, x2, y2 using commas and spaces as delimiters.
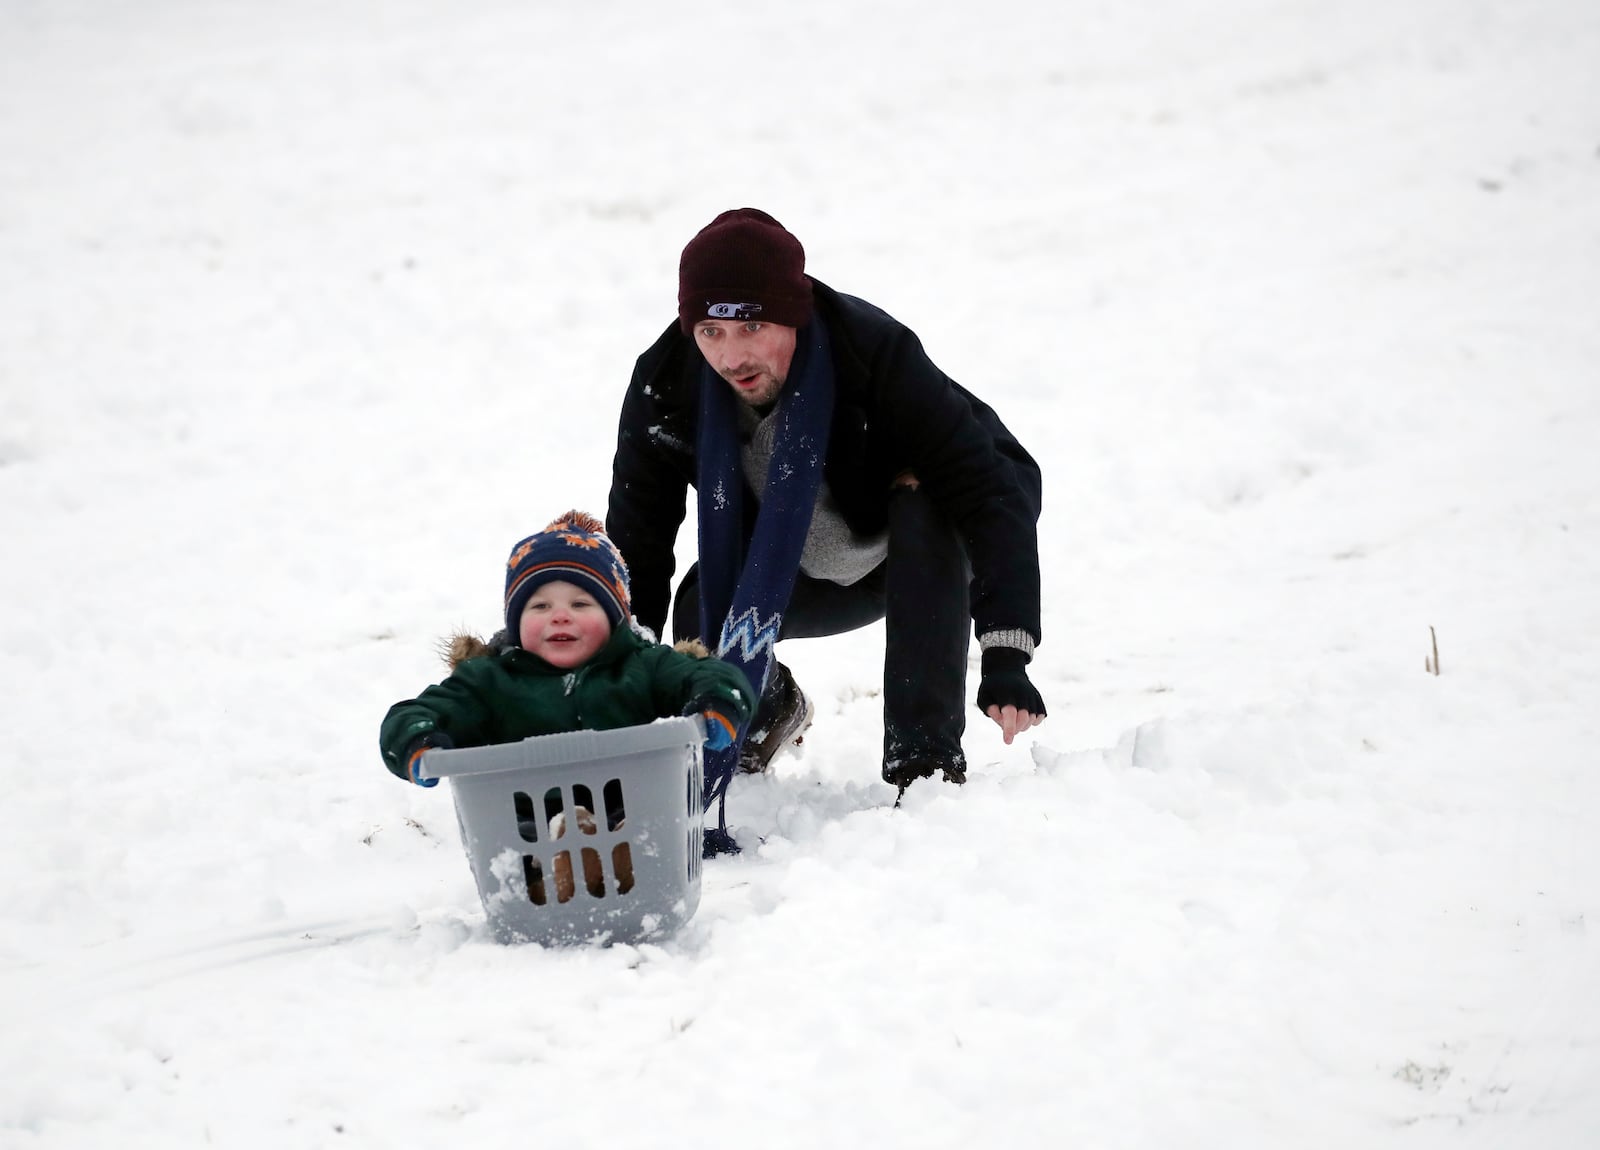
606, 208, 1045, 793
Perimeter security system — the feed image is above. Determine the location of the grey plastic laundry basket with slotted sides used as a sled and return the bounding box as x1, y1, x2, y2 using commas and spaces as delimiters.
421, 717, 706, 944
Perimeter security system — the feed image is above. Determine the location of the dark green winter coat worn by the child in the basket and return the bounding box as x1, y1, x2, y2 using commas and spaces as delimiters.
378, 627, 755, 779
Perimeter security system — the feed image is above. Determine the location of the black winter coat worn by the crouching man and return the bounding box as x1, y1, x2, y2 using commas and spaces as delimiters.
606, 280, 1043, 641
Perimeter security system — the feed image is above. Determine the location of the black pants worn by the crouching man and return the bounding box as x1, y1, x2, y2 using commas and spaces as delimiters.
672, 488, 971, 768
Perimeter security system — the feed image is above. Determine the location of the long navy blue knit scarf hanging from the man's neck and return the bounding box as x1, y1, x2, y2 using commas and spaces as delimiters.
696, 317, 834, 854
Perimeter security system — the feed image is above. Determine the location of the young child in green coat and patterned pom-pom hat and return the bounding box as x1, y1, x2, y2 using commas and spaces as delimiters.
378, 510, 755, 902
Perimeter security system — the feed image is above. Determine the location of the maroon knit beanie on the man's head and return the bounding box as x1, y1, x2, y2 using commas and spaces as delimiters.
678, 208, 811, 334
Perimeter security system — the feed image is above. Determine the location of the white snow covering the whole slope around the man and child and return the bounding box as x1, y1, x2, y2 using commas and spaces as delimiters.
0, 0, 1600, 1150
